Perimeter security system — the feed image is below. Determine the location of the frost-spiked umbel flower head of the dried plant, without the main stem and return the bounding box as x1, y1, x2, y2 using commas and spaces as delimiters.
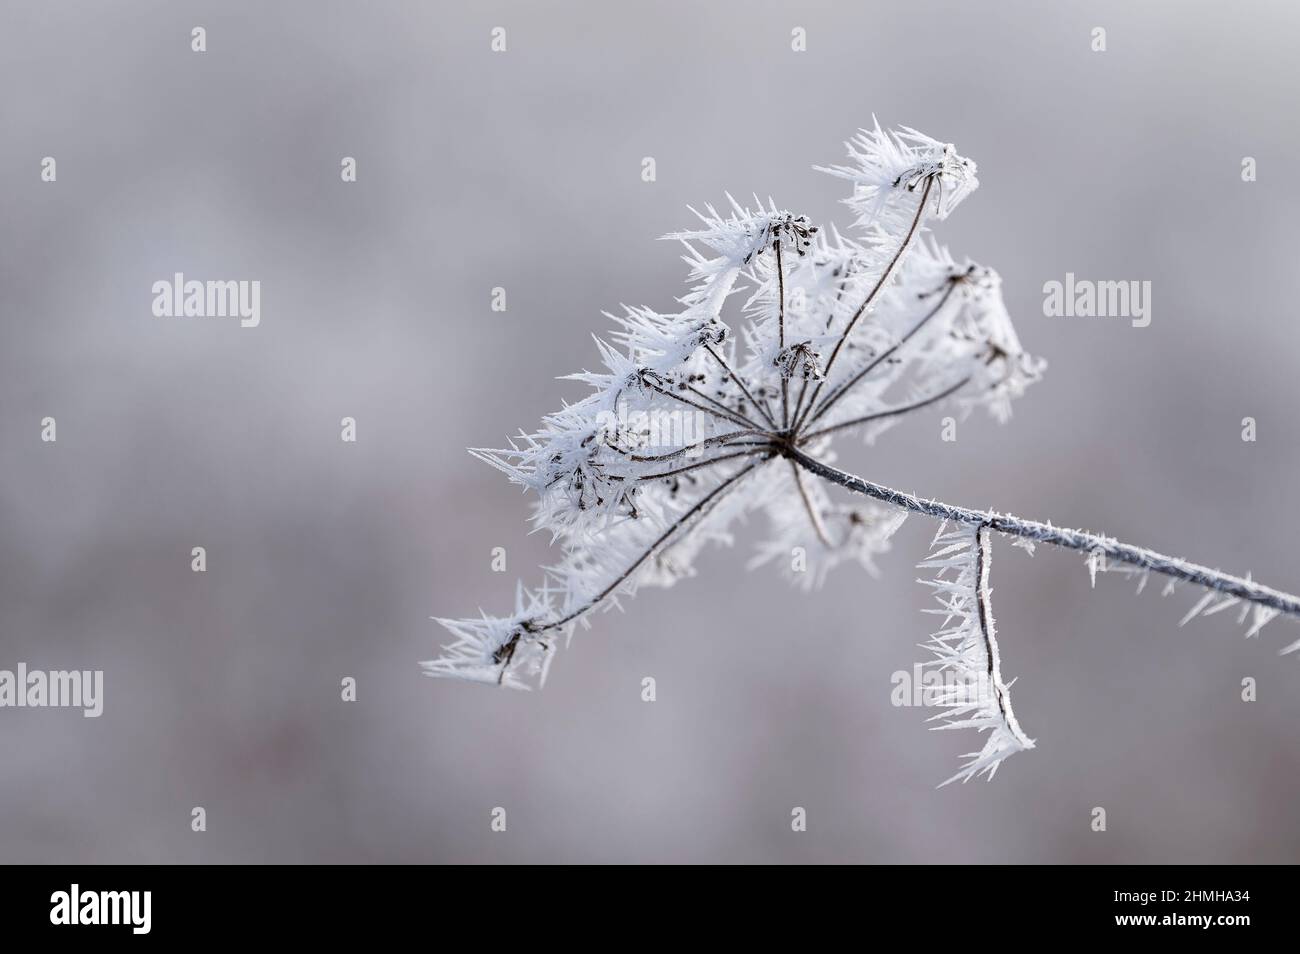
428, 126, 1024, 685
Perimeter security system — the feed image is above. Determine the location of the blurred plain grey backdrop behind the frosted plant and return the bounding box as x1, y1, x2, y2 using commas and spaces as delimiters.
0, 0, 1300, 863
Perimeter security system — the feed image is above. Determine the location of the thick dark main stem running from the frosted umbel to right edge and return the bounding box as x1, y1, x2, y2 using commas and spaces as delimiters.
783, 446, 1300, 616
